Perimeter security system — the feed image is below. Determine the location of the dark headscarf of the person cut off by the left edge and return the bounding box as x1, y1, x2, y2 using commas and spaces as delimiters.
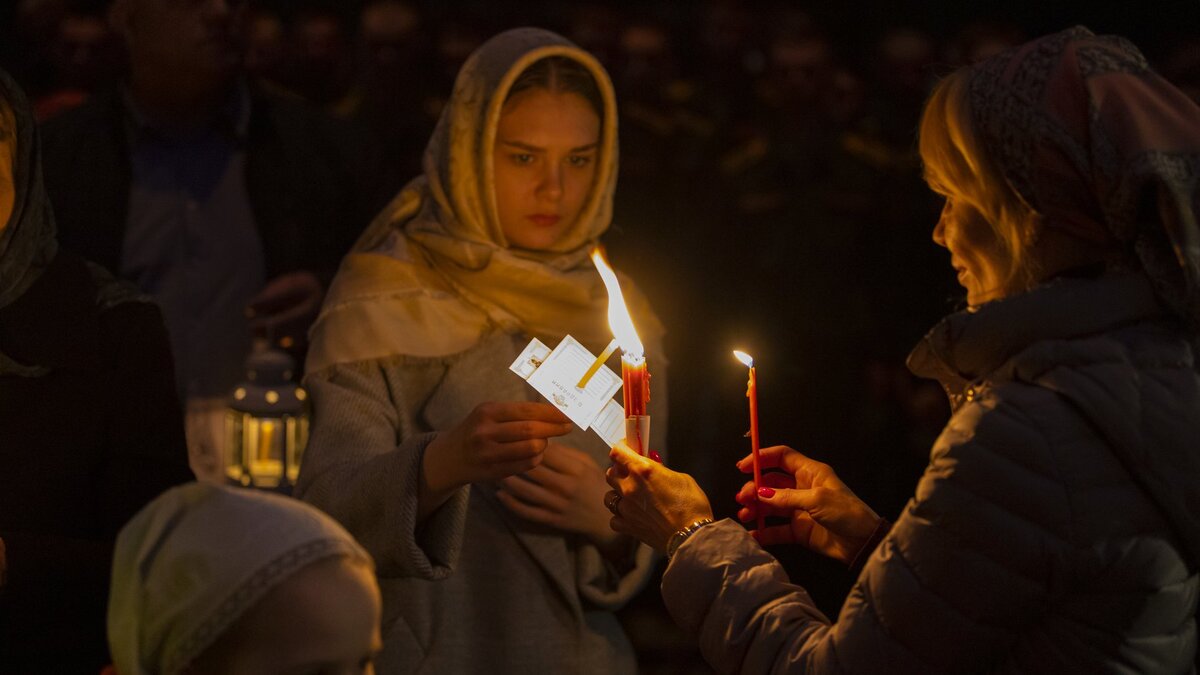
0, 70, 59, 377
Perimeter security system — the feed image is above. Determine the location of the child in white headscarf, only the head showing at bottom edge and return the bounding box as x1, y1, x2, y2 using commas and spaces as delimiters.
104, 483, 380, 675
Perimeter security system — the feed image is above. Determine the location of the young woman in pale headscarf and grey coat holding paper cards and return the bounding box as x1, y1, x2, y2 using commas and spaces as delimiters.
296, 29, 666, 674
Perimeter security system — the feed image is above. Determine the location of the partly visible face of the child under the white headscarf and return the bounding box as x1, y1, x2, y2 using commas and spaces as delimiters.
185, 557, 383, 675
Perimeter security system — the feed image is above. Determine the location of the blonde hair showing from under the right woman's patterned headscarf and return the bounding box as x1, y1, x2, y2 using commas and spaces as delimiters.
919, 68, 1038, 289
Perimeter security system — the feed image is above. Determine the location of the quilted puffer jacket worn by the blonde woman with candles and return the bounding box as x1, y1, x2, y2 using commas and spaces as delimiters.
662, 276, 1200, 673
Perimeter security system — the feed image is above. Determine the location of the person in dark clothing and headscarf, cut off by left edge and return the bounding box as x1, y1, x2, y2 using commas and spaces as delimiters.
0, 66, 191, 674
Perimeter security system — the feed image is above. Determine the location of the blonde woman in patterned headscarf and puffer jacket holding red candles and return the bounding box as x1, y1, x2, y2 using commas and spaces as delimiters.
610, 28, 1200, 673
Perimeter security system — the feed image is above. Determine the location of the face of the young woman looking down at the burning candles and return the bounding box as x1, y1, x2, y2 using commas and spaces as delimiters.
492, 89, 600, 251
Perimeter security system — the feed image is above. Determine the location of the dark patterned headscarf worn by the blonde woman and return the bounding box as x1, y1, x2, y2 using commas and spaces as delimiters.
967, 26, 1200, 328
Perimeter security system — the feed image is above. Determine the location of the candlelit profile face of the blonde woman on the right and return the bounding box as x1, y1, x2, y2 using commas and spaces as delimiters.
934, 195, 1013, 307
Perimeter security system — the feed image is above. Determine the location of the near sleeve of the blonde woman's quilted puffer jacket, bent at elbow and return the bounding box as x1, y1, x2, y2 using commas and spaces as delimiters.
662, 394, 1070, 673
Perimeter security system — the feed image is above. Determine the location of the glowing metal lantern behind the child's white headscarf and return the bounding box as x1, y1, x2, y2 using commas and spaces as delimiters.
224, 347, 308, 492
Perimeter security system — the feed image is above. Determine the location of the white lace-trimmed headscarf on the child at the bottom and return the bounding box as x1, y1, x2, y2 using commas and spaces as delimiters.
108, 483, 373, 675
